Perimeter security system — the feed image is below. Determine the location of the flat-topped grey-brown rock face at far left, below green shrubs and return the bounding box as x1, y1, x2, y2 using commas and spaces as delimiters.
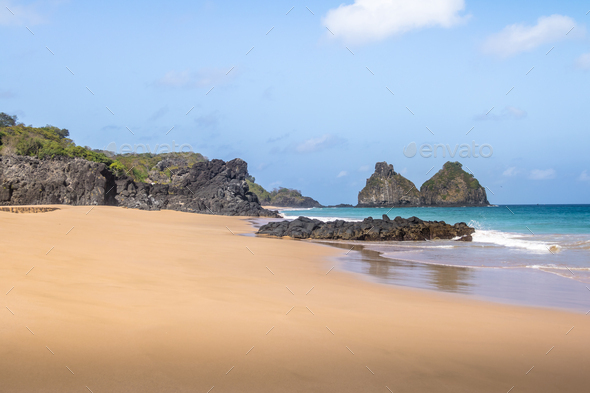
0, 156, 116, 205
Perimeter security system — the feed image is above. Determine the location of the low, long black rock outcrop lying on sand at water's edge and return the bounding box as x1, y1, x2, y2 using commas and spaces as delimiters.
257, 215, 475, 241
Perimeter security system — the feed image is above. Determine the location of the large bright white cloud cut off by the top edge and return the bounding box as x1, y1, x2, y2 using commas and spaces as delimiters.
322, 0, 465, 44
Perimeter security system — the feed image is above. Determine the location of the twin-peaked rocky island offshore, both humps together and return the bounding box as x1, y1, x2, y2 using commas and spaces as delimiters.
357, 161, 490, 207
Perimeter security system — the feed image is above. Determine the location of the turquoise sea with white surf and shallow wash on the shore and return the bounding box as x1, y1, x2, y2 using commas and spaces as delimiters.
281, 205, 590, 310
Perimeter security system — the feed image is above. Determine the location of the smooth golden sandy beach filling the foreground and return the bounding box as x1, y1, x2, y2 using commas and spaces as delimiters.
0, 206, 590, 393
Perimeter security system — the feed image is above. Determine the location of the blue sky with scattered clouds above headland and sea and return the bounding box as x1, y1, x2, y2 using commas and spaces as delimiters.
0, 0, 590, 204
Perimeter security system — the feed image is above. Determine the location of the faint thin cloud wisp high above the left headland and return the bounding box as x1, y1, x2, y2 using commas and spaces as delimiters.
156, 68, 235, 89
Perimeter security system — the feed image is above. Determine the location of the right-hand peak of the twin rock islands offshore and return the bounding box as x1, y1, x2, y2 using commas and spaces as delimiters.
420, 162, 489, 206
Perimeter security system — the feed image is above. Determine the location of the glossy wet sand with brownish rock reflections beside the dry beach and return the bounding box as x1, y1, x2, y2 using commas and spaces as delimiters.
317, 242, 590, 312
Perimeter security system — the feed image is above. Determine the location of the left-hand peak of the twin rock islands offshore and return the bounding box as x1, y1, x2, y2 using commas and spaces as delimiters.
357, 162, 420, 207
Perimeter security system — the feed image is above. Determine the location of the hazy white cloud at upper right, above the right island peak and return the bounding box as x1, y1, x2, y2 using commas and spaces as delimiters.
483, 15, 584, 57
